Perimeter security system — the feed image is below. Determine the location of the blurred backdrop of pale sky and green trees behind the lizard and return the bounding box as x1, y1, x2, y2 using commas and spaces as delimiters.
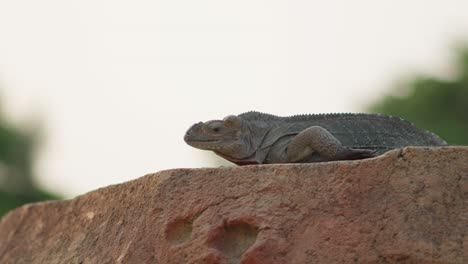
0, 0, 468, 216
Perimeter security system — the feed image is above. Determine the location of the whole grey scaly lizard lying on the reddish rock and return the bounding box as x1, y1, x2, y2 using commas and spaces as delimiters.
184, 111, 447, 165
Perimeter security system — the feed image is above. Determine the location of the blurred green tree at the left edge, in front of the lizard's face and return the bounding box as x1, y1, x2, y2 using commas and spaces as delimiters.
0, 99, 58, 217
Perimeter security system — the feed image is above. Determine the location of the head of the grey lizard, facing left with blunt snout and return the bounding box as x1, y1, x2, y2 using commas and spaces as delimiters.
184, 115, 252, 159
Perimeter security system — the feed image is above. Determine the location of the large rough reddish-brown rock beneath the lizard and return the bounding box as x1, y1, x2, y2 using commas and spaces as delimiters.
0, 147, 468, 264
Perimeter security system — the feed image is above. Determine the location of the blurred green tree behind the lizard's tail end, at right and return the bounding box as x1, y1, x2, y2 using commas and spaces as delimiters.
369, 46, 468, 145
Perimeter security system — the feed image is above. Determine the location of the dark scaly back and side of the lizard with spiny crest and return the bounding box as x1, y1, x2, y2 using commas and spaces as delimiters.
239, 112, 447, 154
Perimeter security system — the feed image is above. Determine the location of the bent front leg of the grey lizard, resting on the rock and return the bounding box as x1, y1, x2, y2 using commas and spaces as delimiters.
286, 126, 375, 163
